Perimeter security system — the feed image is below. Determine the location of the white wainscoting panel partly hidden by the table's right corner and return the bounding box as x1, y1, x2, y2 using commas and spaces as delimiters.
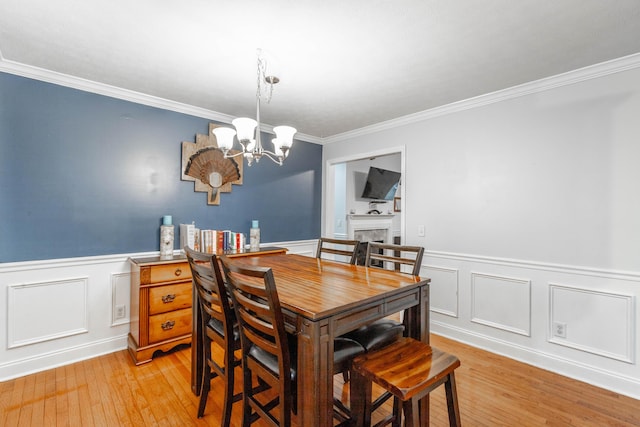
420, 265, 458, 317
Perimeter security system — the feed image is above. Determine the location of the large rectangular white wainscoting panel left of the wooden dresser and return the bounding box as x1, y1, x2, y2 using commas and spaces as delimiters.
7, 277, 88, 348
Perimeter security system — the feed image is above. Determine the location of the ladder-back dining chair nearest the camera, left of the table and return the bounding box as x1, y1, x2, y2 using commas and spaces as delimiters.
220, 256, 297, 427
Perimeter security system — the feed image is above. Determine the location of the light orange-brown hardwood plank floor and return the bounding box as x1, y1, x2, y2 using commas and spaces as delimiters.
0, 336, 640, 427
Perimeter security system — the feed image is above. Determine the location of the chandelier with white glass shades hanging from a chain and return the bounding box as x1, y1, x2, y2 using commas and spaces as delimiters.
212, 49, 297, 166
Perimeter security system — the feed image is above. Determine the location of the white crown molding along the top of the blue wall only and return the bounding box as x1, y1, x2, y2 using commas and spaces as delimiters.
0, 56, 322, 144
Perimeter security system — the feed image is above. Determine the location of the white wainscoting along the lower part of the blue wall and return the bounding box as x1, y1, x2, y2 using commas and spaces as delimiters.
0, 240, 317, 381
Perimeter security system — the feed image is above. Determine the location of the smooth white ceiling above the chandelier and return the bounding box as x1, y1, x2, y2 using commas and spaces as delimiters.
0, 0, 640, 138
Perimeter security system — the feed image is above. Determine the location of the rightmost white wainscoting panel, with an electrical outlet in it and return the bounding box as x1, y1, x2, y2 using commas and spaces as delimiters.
549, 283, 635, 363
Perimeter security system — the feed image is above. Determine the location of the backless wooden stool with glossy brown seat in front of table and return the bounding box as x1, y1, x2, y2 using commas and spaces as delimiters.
351, 337, 460, 427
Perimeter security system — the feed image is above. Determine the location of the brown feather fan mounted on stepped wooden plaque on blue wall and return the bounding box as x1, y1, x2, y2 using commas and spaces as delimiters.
182, 123, 243, 205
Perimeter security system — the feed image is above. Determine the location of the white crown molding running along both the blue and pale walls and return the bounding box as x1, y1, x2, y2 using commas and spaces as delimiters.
0, 52, 640, 145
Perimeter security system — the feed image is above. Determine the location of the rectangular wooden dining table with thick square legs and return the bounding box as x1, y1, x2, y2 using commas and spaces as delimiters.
192, 254, 430, 427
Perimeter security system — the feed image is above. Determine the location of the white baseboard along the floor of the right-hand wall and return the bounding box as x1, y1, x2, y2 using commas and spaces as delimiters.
431, 320, 640, 399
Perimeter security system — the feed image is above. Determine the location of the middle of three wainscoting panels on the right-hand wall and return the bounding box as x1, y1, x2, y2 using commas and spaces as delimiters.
471, 273, 531, 336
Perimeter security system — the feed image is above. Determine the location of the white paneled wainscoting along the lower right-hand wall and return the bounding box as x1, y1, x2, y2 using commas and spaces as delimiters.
421, 251, 640, 399
